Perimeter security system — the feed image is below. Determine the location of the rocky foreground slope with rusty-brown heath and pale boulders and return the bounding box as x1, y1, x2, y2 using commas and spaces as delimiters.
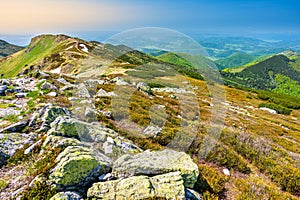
0, 36, 300, 200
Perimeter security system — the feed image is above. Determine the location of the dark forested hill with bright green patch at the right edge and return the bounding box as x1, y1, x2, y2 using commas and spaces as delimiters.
221, 54, 300, 96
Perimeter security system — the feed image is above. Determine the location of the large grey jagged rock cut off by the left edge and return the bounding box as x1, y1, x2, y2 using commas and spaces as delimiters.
0, 133, 37, 167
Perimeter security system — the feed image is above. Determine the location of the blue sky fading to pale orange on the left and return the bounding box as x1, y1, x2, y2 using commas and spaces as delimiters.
0, 0, 300, 44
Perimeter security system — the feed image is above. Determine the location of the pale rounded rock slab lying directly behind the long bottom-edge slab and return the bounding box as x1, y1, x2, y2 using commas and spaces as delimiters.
112, 149, 199, 188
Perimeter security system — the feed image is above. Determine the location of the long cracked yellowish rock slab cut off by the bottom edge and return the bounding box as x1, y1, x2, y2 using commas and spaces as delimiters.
87, 172, 185, 200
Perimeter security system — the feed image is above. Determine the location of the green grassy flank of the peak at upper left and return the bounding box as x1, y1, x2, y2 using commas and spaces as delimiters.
0, 35, 91, 77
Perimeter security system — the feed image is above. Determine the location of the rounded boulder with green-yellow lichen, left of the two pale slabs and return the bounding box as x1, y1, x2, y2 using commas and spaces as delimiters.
49, 146, 111, 189
